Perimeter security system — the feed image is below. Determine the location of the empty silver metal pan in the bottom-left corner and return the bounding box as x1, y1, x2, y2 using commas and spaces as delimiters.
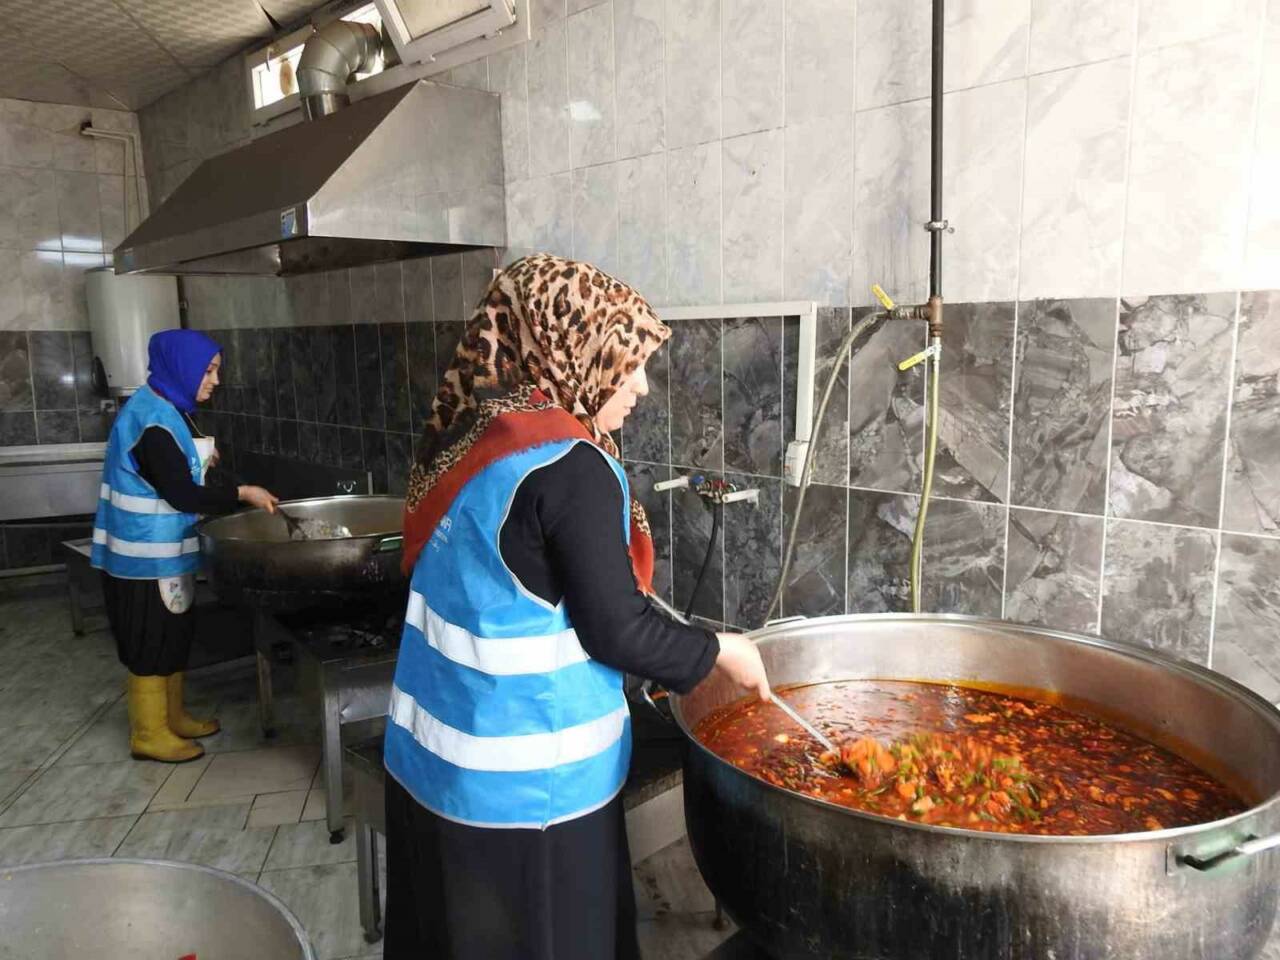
0, 860, 315, 960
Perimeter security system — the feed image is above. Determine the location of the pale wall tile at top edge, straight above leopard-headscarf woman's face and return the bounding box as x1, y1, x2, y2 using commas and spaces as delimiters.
613, 0, 667, 157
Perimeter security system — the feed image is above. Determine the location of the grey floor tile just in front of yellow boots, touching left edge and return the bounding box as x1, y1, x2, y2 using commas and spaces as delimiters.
0, 760, 173, 827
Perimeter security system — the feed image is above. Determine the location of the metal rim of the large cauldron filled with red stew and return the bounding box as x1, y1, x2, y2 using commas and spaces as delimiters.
671, 613, 1280, 846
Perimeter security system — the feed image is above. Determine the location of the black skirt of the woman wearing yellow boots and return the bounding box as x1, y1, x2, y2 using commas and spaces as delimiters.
102, 572, 196, 677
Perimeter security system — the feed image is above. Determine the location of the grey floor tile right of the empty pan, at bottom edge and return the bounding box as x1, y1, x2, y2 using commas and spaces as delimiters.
259, 863, 369, 960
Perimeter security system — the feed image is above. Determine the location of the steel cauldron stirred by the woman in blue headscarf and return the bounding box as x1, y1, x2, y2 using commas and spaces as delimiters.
197, 497, 406, 609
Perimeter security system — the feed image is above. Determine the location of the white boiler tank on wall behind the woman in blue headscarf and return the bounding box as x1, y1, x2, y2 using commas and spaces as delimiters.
86, 266, 180, 397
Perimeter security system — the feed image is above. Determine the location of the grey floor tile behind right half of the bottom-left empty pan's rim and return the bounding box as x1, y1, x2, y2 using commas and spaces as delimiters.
116, 804, 275, 874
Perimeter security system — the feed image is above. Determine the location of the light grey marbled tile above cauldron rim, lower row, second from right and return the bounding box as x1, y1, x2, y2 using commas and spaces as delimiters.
1101, 520, 1217, 664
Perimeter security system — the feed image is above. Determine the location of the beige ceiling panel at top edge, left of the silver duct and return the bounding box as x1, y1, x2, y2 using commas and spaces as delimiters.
116, 0, 273, 68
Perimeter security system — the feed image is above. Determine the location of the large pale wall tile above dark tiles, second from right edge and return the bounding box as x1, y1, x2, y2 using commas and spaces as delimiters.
1120, 32, 1261, 293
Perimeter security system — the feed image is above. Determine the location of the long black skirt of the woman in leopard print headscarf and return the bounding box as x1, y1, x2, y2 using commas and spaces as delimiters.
383, 776, 640, 960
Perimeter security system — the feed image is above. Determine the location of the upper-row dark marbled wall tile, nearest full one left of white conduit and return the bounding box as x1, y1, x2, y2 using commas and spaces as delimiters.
727, 316, 783, 478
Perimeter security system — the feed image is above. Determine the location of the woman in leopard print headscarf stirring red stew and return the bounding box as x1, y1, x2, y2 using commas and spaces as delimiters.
373, 255, 768, 960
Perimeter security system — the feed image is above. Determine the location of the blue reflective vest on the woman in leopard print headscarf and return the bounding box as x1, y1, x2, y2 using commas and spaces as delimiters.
385, 440, 631, 828
